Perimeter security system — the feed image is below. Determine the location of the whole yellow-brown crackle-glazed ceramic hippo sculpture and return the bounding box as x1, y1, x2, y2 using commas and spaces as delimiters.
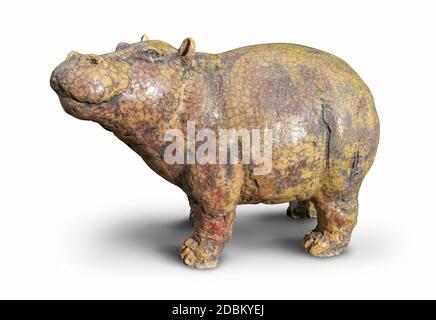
50, 37, 379, 268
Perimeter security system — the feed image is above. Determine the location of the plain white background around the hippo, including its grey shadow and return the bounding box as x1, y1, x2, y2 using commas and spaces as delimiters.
0, 0, 436, 299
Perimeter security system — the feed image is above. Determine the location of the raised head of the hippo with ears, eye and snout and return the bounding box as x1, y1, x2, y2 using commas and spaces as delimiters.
50, 36, 195, 134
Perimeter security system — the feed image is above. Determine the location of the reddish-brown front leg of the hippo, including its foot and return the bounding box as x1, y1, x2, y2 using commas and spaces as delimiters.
179, 165, 242, 269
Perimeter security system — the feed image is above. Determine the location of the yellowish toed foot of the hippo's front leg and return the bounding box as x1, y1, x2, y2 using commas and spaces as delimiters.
179, 238, 220, 269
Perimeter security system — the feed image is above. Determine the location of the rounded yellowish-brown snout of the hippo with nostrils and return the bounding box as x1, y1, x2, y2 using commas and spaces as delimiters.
50, 51, 128, 104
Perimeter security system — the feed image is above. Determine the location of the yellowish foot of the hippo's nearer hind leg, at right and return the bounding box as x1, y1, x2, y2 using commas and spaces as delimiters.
302, 231, 350, 257
